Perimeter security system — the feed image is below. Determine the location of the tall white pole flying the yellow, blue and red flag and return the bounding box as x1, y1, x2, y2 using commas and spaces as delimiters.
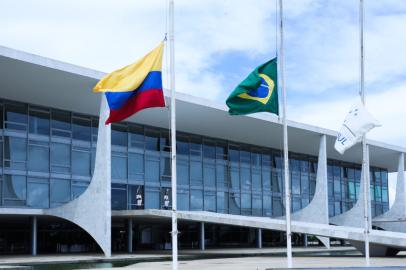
169, 0, 178, 270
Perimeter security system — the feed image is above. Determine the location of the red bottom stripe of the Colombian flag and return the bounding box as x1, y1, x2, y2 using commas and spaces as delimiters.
106, 89, 165, 125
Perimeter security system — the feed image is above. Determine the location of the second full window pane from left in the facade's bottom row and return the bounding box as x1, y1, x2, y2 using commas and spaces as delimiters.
27, 179, 49, 208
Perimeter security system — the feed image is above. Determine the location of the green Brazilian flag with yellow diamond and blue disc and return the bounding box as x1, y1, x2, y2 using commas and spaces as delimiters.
226, 58, 279, 115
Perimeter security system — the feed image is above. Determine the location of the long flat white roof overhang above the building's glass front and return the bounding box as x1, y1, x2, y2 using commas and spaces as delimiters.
0, 46, 406, 172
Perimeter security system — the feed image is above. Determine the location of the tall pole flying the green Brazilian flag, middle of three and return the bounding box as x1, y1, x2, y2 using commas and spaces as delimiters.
278, 0, 292, 268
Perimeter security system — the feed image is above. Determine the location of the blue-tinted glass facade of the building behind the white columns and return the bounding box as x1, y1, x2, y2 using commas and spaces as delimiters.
0, 100, 389, 217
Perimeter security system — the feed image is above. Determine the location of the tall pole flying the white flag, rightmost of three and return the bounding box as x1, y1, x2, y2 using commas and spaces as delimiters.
359, 0, 370, 266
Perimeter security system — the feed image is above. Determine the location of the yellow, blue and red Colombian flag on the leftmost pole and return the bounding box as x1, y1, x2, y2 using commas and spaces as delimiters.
93, 41, 165, 125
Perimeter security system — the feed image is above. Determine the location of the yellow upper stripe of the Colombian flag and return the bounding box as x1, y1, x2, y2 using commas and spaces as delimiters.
93, 41, 164, 92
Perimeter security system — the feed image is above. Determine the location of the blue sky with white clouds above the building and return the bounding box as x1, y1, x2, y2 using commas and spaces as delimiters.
0, 0, 406, 202
